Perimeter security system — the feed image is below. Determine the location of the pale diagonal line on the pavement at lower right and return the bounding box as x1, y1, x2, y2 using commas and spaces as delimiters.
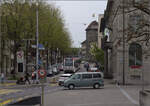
116, 85, 139, 105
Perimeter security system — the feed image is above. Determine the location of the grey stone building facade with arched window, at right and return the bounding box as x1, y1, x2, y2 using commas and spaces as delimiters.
105, 0, 150, 84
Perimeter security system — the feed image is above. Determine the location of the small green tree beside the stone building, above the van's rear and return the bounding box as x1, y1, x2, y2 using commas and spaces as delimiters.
90, 44, 104, 65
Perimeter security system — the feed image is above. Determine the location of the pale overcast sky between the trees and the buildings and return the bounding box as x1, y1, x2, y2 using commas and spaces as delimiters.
49, 1, 107, 47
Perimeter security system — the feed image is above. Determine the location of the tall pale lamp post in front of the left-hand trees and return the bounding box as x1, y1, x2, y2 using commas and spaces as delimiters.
36, 0, 39, 83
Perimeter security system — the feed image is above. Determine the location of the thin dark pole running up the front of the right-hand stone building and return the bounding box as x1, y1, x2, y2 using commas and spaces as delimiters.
122, 0, 125, 85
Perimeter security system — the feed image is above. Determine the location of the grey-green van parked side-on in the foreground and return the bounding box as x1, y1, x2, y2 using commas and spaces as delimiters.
64, 72, 104, 89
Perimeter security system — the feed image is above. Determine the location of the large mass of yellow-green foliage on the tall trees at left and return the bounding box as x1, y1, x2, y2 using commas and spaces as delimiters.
1, 0, 72, 53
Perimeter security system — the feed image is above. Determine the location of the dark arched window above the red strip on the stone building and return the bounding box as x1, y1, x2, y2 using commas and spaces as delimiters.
129, 43, 142, 68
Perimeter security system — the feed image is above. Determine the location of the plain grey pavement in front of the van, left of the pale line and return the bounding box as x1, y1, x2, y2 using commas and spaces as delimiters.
45, 84, 138, 106
